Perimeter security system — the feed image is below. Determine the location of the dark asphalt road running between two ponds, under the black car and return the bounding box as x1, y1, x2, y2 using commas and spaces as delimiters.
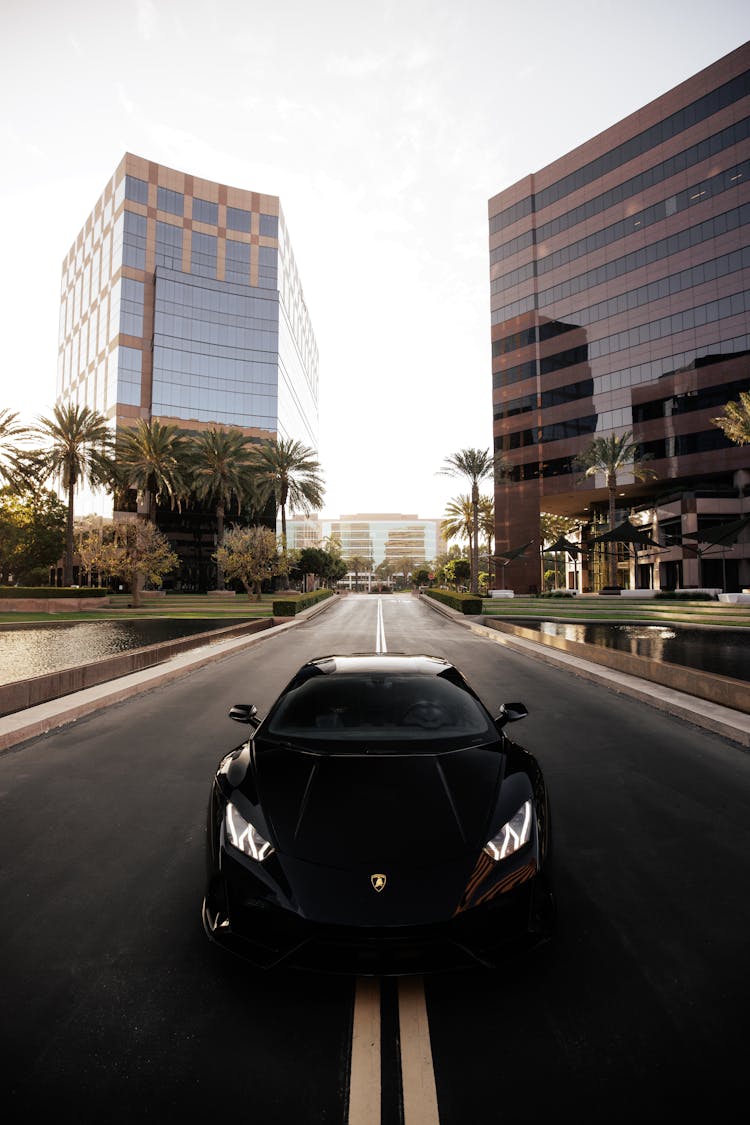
0, 596, 750, 1125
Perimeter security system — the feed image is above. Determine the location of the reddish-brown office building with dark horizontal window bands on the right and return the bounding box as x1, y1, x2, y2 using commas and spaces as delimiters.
489, 44, 750, 592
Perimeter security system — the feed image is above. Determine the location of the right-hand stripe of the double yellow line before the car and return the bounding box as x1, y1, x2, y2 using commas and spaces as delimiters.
398, 977, 440, 1125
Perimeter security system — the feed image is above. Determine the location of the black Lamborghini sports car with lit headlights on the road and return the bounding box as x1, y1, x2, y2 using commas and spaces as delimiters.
202, 654, 554, 974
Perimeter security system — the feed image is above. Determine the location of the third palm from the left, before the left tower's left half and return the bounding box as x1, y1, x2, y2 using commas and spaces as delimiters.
117, 419, 190, 523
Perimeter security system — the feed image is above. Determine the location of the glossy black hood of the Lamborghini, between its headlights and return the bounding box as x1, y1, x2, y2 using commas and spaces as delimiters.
253, 743, 504, 867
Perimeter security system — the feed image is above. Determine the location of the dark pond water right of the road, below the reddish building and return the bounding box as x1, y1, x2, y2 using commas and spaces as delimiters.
514, 619, 750, 681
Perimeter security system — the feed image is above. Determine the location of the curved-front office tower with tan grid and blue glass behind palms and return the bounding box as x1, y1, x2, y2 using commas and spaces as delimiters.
57, 153, 318, 586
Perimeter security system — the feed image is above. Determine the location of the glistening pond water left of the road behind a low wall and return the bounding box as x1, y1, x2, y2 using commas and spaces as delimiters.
0, 618, 244, 684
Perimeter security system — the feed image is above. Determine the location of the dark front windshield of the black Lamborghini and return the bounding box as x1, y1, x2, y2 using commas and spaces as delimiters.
265, 673, 497, 741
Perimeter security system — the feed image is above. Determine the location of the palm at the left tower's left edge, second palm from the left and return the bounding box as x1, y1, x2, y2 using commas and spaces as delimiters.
29, 403, 112, 586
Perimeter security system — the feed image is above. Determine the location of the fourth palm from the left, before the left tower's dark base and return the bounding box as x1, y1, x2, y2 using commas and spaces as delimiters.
190, 426, 256, 590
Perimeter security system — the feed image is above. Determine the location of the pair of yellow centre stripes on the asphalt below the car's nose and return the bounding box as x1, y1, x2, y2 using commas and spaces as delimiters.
347, 977, 440, 1125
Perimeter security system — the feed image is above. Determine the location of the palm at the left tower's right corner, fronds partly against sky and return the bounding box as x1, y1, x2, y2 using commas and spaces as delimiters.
252, 438, 324, 551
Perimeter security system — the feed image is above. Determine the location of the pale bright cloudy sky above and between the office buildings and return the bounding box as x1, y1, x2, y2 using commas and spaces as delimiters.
0, 0, 750, 519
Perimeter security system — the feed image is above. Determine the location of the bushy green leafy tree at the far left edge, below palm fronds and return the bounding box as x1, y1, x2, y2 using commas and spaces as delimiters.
0, 487, 66, 586
